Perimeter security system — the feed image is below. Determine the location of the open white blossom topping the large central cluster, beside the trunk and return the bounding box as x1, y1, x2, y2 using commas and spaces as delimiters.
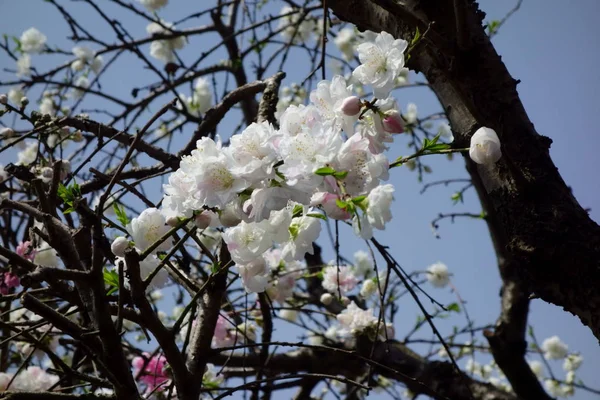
353, 32, 408, 98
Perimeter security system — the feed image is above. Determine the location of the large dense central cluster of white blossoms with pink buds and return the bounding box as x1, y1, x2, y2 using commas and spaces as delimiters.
148, 33, 406, 292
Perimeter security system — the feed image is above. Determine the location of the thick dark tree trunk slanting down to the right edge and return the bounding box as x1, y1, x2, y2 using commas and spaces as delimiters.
327, 0, 600, 338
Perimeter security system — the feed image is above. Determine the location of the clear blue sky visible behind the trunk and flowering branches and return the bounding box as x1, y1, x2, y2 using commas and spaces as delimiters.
0, 0, 600, 400
